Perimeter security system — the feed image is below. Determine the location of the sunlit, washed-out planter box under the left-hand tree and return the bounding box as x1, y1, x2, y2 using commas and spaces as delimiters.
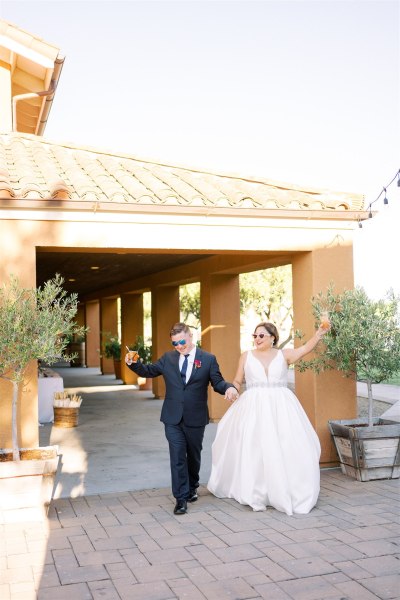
0, 446, 60, 510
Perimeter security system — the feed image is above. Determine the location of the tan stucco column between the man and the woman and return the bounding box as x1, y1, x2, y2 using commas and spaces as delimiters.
200, 275, 240, 421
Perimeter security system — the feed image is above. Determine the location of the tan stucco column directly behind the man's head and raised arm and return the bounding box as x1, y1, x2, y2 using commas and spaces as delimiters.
151, 285, 180, 398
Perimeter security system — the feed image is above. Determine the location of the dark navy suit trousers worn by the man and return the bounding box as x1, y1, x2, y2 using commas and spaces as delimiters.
164, 420, 205, 500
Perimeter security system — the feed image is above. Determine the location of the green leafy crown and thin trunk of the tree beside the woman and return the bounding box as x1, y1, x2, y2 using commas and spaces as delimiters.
297, 286, 400, 425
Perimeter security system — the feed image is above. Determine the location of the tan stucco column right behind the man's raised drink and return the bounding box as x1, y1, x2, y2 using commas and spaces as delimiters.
121, 294, 143, 384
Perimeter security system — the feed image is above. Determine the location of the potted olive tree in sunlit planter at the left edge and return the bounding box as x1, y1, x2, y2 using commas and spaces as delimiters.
0, 275, 84, 508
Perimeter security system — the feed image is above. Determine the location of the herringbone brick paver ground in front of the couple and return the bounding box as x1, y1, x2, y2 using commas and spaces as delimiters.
0, 469, 400, 600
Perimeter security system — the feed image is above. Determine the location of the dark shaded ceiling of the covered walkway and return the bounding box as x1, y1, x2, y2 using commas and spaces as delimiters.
36, 250, 211, 297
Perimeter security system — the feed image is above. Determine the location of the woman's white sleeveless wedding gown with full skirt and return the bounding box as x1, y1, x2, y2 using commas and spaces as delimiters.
207, 350, 321, 515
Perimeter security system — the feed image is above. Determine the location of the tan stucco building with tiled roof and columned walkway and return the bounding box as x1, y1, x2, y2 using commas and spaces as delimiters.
0, 22, 366, 465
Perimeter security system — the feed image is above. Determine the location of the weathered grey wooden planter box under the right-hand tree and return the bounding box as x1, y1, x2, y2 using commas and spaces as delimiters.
328, 419, 400, 481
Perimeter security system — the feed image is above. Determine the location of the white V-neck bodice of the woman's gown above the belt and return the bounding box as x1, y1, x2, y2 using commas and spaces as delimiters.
244, 350, 288, 389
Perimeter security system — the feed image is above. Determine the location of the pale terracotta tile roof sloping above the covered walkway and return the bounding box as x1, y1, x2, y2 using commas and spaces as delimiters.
0, 133, 363, 211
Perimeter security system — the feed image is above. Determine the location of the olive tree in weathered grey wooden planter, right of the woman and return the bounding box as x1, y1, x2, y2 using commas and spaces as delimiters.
297, 286, 400, 481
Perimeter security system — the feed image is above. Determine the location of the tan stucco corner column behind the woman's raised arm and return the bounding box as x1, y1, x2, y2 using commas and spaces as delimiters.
292, 245, 357, 466
